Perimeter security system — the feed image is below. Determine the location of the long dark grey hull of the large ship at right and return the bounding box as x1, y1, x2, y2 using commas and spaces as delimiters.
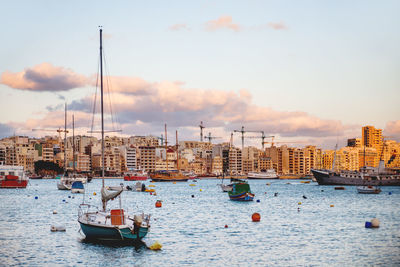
311, 170, 400, 186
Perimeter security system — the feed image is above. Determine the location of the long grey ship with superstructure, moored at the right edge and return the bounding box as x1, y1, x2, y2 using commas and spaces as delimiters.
311, 167, 400, 186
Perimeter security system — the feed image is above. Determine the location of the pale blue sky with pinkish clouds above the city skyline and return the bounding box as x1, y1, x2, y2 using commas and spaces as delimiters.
0, 0, 400, 149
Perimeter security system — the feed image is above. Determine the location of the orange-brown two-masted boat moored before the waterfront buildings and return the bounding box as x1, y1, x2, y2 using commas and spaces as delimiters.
150, 124, 189, 182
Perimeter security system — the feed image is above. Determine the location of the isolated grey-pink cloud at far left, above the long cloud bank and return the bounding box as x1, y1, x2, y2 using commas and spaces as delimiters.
0, 63, 89, 92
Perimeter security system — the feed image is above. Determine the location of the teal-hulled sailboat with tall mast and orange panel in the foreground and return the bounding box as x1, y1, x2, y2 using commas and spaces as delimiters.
78, 28, 150, 242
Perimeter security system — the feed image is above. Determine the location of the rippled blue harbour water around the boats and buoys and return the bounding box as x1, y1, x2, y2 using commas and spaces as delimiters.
0, 180, 400, 266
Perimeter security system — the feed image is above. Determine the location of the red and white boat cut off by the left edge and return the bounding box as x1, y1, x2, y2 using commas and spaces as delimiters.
0, 165, 29, 188
